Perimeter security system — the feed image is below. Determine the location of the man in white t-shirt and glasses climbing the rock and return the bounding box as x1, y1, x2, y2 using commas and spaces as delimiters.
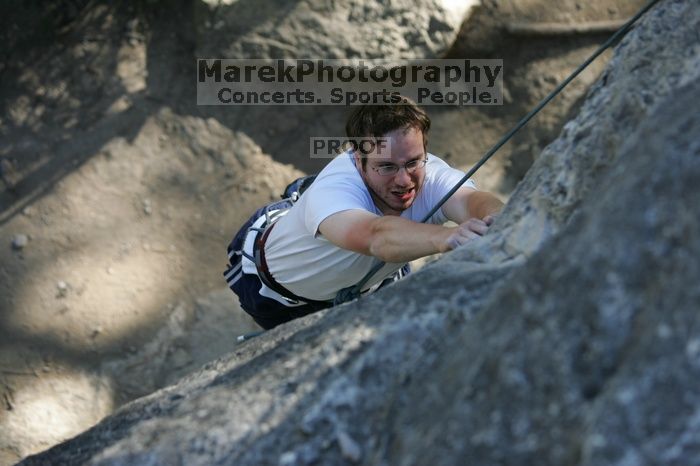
224, 99, 503, 329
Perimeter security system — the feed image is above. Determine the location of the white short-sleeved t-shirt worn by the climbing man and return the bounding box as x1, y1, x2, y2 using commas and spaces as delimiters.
265, 152, 475, 300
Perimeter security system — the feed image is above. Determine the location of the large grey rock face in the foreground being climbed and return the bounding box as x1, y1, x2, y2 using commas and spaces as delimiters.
16, 0, 700, 465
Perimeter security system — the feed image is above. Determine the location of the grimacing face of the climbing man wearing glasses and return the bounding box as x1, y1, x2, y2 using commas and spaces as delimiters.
355, 128, 427, 215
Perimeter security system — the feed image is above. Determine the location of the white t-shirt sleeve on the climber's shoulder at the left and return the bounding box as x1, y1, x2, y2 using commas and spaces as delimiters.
303, 176, 371, 236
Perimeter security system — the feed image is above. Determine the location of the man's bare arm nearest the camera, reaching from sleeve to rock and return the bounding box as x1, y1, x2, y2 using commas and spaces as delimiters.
318, 209, 488, 262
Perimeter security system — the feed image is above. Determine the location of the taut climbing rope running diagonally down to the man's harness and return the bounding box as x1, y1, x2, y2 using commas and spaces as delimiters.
333, 0, 659, 306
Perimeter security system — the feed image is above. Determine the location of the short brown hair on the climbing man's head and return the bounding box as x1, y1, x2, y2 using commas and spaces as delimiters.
345, 96, 430, 169
